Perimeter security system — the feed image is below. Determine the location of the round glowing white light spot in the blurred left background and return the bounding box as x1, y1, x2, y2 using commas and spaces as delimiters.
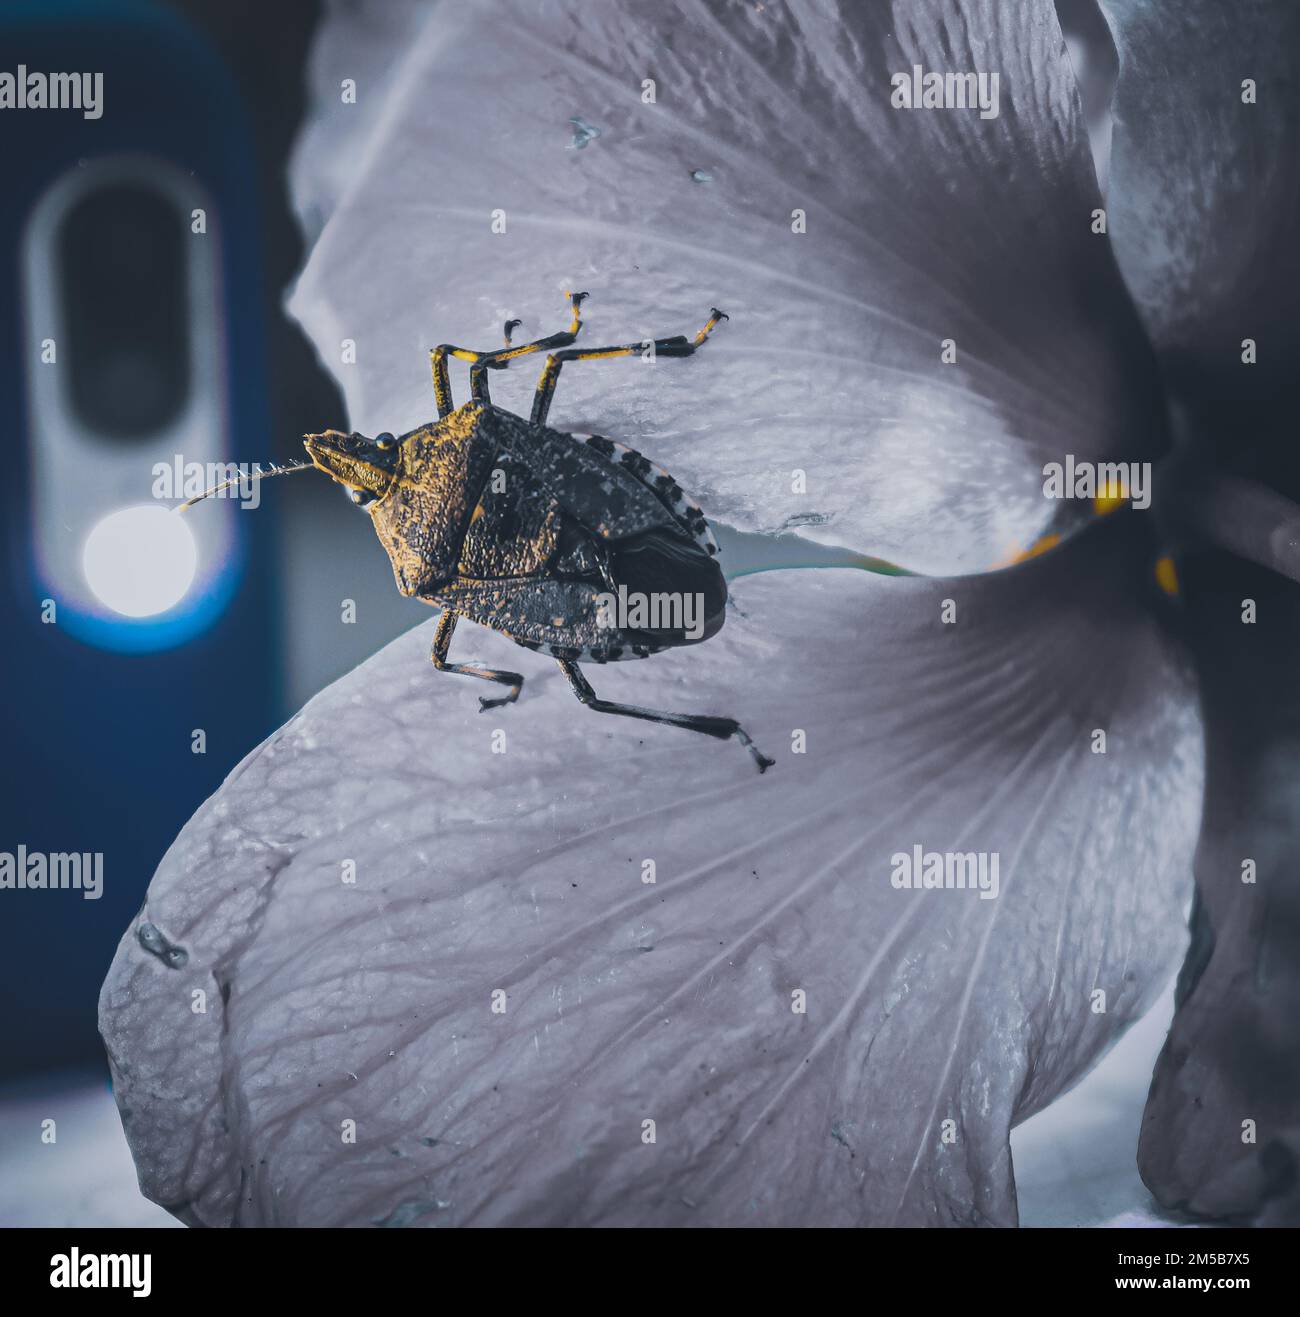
82, 503, 198, 618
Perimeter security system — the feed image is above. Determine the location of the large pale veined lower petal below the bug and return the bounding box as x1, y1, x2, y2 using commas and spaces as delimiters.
100, 524, 1201, 1225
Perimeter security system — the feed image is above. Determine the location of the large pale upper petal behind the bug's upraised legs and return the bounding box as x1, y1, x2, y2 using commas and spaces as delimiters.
291, 0, 1163, 572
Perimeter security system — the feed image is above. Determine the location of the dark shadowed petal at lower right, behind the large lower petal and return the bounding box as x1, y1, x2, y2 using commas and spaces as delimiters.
1138, 568, 1300, 1226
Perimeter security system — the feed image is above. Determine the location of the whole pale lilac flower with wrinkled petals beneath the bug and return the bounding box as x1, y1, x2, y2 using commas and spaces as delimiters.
101, 0, 1296, 1225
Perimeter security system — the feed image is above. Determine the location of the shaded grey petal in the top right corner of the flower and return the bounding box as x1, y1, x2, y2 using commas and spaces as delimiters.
1101, 0, 1300, 381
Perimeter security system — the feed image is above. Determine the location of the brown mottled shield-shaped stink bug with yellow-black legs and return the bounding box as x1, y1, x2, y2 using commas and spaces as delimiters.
304, 300, 772, 772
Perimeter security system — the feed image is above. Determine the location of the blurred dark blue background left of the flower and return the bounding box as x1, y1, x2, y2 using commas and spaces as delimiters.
0, 0, 425, 1076
